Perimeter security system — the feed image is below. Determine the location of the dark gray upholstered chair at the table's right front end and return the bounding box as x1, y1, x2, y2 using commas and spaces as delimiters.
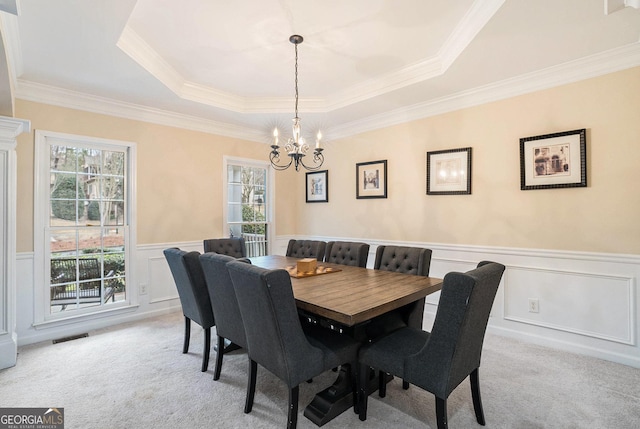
358, 262, 505, 429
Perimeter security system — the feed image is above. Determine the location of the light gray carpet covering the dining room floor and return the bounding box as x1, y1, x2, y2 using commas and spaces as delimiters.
0, 313, 640, 429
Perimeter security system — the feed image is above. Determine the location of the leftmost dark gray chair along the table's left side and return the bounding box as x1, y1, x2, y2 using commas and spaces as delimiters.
164, 248, 215, 372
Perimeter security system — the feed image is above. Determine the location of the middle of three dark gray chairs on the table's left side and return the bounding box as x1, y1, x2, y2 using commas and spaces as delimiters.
200, 252, 251, 380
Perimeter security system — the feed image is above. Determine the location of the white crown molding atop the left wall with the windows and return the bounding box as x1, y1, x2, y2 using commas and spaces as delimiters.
16, 79, 265, 143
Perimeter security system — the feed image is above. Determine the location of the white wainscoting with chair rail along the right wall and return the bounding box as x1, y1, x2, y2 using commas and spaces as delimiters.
274, 235, 640, 368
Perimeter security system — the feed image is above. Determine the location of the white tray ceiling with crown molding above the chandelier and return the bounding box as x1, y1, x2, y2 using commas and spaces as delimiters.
0, 0, 640, 142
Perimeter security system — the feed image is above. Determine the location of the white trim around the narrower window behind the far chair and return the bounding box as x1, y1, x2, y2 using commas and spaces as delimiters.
222, 155, 276, 255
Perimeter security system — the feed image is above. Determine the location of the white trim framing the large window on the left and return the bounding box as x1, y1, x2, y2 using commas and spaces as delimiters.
33, 130, 138, 327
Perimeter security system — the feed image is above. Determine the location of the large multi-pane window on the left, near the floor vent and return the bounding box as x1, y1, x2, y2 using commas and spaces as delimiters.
34, 131, 135, 321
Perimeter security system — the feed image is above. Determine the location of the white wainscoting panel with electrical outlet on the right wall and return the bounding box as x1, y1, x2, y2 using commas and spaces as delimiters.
504, 267, 635, 345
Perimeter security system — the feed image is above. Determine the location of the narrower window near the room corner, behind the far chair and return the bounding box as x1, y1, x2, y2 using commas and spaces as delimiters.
225, 159, 273, 257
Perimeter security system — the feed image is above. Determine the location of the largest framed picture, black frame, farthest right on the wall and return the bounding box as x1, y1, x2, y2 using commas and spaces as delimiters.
520, 128, 587, 191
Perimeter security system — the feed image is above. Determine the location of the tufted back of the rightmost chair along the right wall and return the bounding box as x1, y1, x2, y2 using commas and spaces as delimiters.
373, 246, 431, 276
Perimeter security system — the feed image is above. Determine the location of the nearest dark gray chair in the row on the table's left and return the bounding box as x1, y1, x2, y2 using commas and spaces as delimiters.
227, 261, 360, 428
